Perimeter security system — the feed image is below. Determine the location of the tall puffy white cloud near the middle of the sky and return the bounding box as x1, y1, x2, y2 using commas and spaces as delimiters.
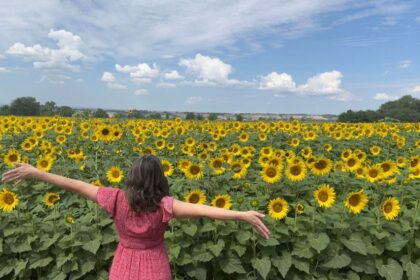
178, 54, 249, 86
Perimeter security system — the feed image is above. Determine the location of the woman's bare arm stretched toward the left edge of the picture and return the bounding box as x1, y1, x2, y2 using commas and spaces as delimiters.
2, 163, 99, 202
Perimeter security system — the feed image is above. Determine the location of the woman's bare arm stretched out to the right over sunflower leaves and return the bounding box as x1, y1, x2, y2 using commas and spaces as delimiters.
173, 199, 270, 239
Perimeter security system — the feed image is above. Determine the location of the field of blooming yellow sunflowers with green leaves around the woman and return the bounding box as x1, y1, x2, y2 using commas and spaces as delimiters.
0, 116, 420, 280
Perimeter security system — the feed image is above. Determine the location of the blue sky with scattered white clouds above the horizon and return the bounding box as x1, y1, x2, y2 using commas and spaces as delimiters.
0, 0, 420, 114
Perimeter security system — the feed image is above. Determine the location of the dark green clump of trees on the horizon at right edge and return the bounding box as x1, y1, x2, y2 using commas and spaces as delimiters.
338, 95, 420, 122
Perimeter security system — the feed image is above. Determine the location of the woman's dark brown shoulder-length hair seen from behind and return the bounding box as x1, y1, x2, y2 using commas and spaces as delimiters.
125, 154, 169, 214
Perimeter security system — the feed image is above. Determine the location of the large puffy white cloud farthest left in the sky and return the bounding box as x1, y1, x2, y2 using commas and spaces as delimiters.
6, 29, 86, 71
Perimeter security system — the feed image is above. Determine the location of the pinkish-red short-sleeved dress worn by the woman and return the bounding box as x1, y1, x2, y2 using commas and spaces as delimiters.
96, 187, 173, 280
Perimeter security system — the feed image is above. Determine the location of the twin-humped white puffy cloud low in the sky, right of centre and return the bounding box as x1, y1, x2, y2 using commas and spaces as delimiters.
258, 70, 353, 101
